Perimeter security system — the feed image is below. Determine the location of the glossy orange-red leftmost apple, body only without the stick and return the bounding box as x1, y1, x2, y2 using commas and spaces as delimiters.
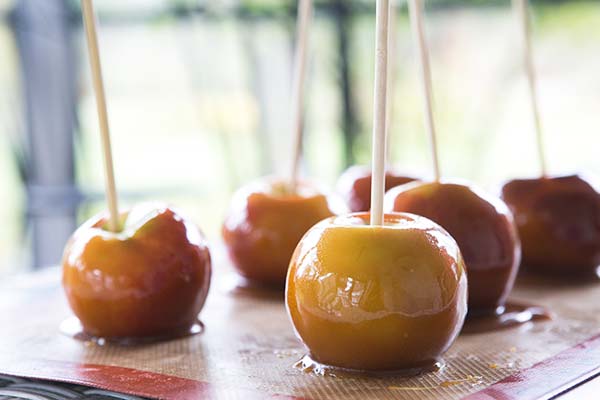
63, 204, 211, 339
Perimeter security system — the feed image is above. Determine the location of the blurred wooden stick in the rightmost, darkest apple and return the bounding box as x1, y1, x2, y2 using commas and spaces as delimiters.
513, 0, 547, 176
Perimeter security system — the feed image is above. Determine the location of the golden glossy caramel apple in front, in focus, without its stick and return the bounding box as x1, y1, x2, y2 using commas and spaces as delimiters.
285, 213, 467, 371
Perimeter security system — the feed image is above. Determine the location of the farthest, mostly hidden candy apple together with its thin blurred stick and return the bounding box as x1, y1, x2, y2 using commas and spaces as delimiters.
337, 1, 415, 212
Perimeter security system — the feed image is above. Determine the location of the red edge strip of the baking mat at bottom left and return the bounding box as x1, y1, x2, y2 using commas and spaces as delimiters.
0, 356, 302, 400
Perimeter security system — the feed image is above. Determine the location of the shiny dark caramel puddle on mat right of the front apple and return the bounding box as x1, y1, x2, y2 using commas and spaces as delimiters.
461, 303, 552, 334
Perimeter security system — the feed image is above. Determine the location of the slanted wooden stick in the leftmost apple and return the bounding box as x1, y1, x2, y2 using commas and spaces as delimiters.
81, 0, 120, 232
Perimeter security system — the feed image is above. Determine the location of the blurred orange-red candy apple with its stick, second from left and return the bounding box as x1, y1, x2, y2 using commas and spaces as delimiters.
222, 0, 344, 288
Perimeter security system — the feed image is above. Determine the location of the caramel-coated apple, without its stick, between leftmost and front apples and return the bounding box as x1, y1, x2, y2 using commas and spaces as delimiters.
222, 179, 344, 287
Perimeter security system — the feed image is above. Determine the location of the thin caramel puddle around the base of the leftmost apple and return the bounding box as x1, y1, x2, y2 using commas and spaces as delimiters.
59, 317, 204, 347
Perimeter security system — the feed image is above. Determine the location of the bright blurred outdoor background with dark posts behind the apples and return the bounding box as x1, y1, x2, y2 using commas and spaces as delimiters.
0, 0, 600, 276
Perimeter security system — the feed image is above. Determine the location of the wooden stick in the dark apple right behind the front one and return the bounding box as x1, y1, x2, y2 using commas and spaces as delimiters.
408, 0, 440, 181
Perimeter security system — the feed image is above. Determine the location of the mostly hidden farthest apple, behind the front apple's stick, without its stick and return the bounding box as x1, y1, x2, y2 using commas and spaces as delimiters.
338, 165, 415, 212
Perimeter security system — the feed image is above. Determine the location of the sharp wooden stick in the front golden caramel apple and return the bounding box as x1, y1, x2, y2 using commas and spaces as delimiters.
371, 0, 390, 226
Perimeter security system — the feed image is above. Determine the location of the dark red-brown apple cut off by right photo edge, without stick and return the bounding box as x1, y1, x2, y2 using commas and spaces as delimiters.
502, 175, 600, 275
